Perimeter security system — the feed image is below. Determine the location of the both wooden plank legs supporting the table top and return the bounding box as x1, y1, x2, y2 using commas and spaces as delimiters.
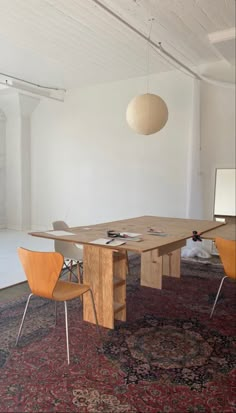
83, 245, 181, 329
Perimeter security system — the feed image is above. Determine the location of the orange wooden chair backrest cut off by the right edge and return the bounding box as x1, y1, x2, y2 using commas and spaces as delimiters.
215, 238, 236, 279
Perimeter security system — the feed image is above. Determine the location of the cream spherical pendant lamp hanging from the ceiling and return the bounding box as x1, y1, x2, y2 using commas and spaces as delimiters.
126, 93, 168, 135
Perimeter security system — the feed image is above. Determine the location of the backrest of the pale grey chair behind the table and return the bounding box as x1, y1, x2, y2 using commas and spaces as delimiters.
52, 221, 83, 261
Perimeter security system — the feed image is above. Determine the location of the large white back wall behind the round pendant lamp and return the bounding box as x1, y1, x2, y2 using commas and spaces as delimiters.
31, 72, 194, 229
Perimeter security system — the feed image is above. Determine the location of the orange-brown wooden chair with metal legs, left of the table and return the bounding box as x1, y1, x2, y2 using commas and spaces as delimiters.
16, 248, 100, 364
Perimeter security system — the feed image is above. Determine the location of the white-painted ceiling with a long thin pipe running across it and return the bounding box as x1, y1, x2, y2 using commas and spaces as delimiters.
0, 0, 235, 89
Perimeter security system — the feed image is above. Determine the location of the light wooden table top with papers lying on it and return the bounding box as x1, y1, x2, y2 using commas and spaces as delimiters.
30, 216, 224, 255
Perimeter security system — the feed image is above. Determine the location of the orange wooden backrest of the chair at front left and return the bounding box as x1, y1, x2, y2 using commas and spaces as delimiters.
17, 248, 64, 298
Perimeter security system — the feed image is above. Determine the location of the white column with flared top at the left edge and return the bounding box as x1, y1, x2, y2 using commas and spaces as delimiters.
0, 90, 40, 230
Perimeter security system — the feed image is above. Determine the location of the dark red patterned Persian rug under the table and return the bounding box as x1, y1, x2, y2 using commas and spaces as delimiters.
0, 257, 236, 413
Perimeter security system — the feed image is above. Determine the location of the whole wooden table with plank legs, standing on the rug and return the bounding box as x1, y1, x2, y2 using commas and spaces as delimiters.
30, 216, 224, 329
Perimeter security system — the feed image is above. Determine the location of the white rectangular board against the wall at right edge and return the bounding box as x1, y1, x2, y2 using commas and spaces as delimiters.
214, 168, 236, 216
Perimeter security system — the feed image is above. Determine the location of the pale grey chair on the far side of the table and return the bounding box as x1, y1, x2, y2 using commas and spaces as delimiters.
52, 221, 83, 283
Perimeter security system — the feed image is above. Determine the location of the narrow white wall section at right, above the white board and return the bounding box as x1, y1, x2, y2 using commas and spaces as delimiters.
201, 82, 236, 219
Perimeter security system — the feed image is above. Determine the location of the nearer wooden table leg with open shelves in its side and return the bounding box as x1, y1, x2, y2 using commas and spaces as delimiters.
83, 245, 127, 329
